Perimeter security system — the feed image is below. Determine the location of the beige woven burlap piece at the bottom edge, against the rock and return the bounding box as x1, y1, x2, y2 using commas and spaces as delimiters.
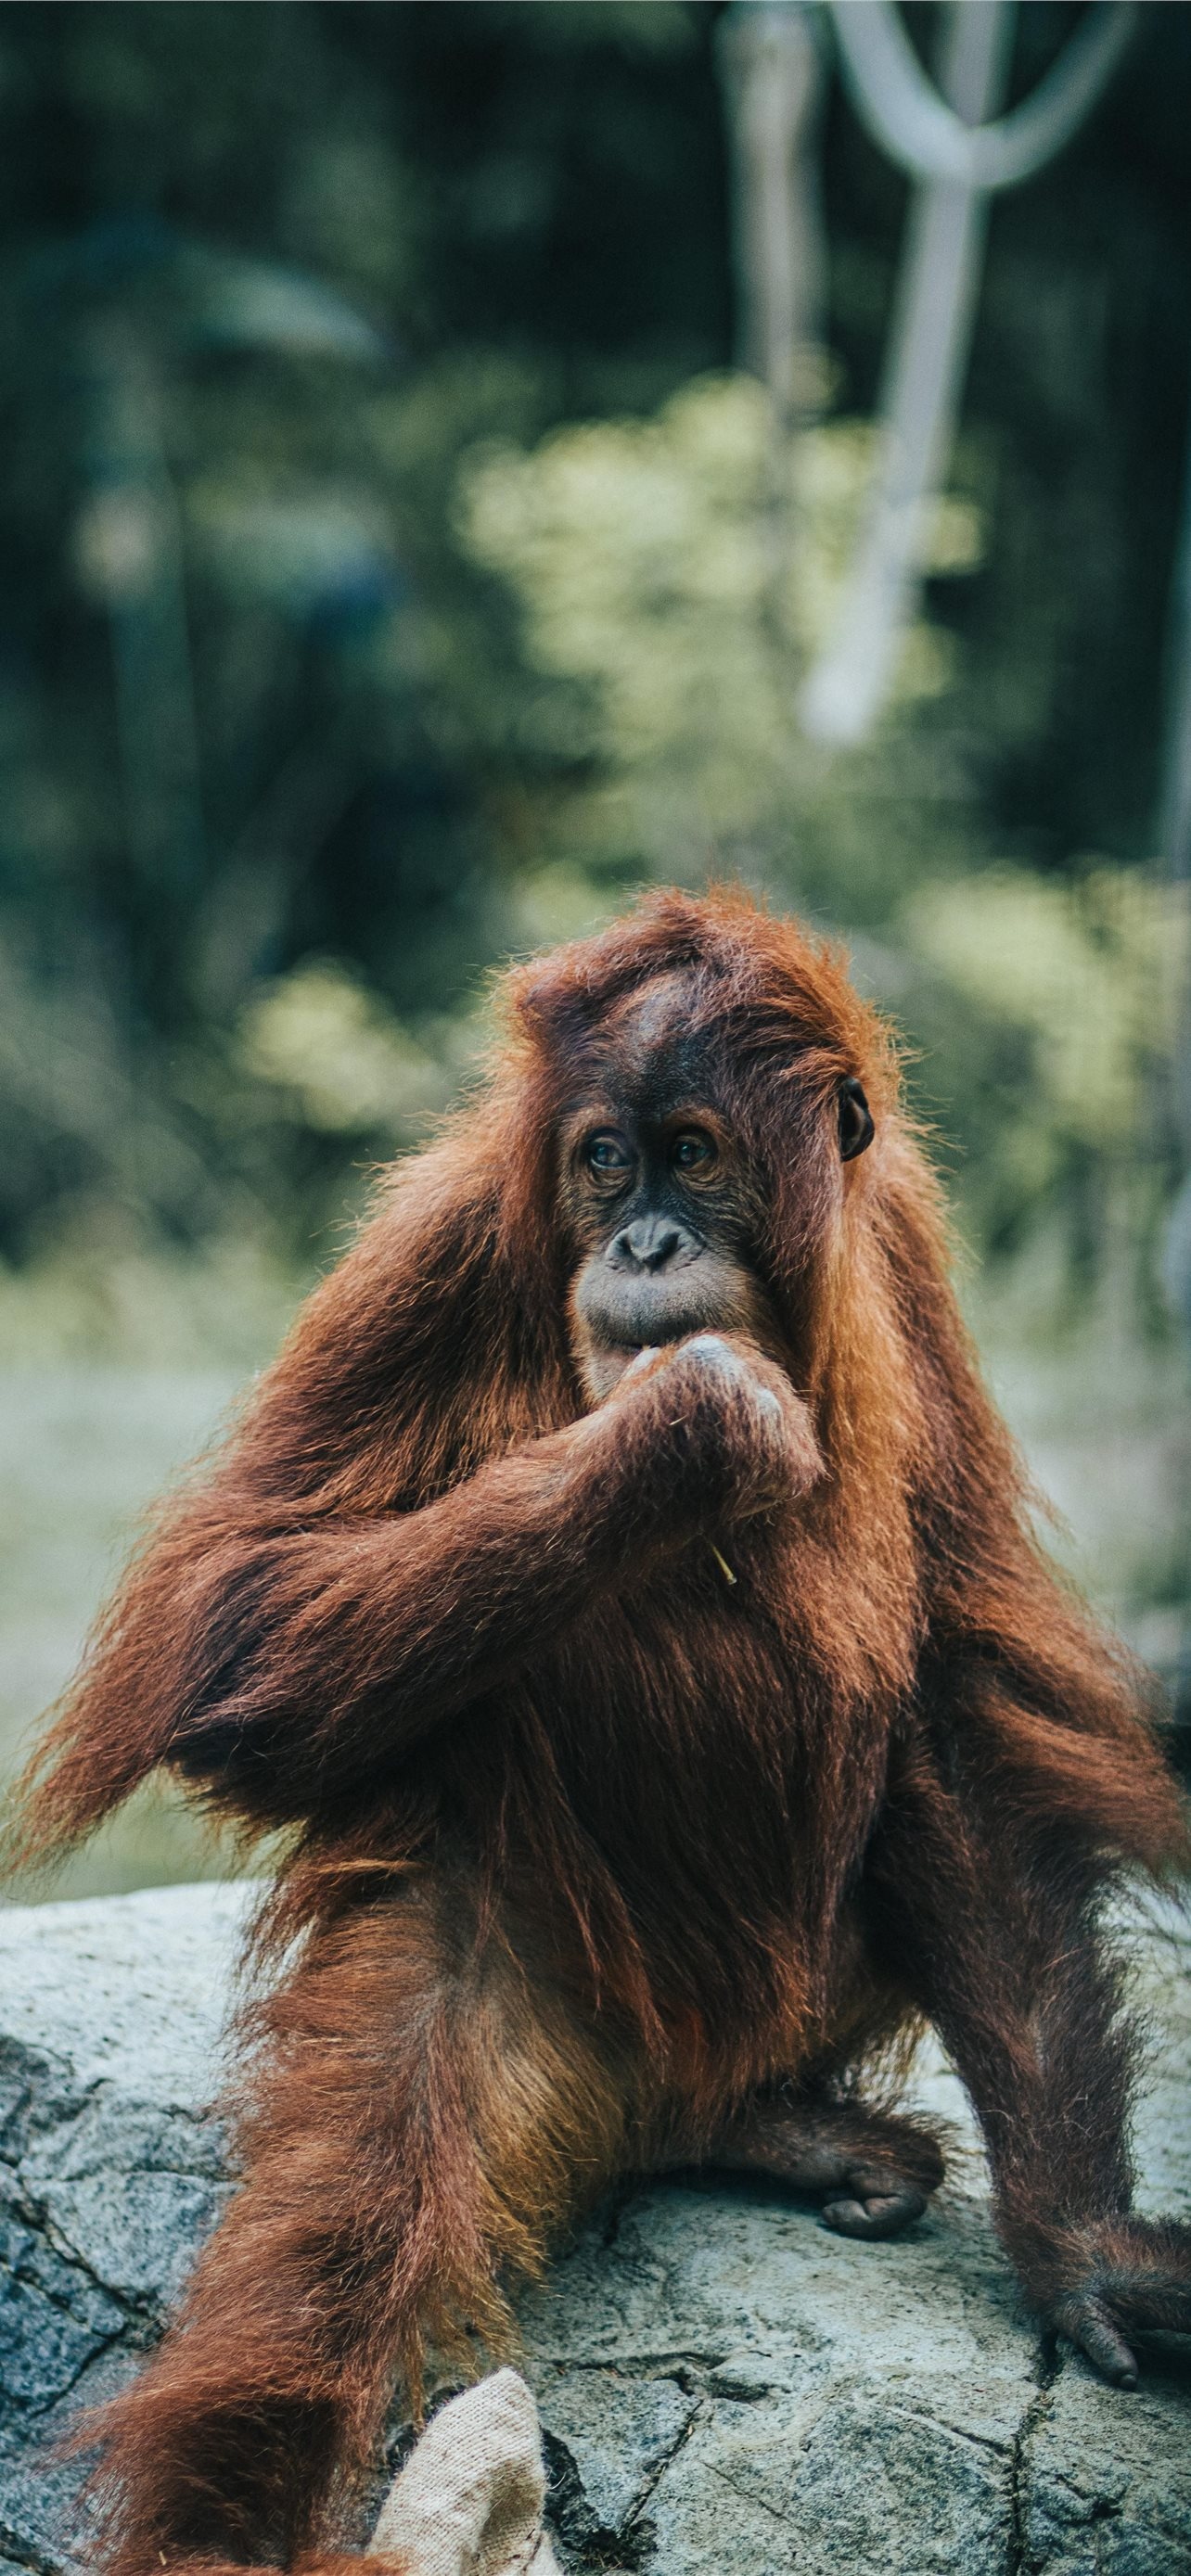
371, 2370, 559, 2576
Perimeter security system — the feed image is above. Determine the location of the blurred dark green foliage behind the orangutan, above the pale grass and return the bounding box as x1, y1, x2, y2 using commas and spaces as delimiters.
0, 0, 1191, 1332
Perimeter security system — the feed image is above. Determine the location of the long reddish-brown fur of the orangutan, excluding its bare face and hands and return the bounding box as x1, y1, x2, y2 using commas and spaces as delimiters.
11, 894, 1185, 2576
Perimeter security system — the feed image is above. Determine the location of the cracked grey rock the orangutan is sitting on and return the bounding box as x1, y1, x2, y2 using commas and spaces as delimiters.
0, 1885, 1191, 2576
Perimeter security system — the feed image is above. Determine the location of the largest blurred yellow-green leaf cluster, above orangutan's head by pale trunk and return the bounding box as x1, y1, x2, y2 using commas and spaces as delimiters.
459, 376, 980, 855
